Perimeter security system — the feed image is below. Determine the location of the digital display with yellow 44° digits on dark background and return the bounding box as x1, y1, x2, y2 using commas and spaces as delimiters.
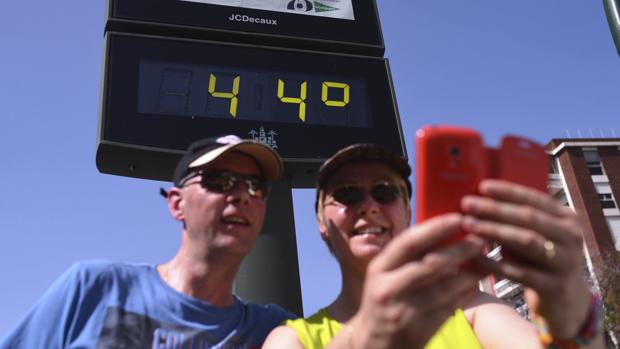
138, 61, 372, 128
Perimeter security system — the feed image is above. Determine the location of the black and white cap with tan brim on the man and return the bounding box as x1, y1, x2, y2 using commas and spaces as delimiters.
173, 135, 283, 187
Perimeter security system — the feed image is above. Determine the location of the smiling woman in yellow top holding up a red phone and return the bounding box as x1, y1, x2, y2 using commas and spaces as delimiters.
264, 144, 603, 349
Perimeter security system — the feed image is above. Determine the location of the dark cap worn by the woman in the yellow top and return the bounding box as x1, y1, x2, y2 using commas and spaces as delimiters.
315, 143, 412, 209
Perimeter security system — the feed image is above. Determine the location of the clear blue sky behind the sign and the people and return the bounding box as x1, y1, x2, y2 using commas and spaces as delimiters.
0, 0, 620, 337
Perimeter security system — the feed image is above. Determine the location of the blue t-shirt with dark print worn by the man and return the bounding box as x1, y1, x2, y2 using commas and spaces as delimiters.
0, 261, 295, 349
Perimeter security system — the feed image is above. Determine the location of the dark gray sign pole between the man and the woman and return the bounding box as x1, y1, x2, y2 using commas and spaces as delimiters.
233, 178, 303, 316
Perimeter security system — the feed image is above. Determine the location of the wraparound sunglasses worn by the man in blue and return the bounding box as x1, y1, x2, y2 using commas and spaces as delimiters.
179, 171, 267, 199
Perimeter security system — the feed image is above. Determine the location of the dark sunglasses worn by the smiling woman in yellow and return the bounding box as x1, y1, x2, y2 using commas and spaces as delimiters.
327, 182, 402, 206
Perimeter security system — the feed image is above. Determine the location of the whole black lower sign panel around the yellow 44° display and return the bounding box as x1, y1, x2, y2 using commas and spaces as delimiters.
97, 33, 406, 186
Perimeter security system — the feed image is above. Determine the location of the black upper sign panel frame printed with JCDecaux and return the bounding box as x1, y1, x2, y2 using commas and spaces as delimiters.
106, 0, 385, 57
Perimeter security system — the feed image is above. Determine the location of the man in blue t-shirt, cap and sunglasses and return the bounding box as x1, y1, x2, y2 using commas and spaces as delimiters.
0, 136, 293, 349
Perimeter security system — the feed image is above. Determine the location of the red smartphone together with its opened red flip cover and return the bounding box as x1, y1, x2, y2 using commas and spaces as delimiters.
416, 126, 549, 243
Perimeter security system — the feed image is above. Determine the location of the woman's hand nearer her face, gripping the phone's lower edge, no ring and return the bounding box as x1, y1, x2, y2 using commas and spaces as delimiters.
348, 214, 484, 349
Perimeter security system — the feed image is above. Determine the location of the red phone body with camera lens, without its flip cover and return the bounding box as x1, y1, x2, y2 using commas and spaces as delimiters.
416, 126, 487, 243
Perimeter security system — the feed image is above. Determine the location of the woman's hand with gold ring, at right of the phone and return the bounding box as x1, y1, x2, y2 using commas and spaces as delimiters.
461, 180, 590, 338
